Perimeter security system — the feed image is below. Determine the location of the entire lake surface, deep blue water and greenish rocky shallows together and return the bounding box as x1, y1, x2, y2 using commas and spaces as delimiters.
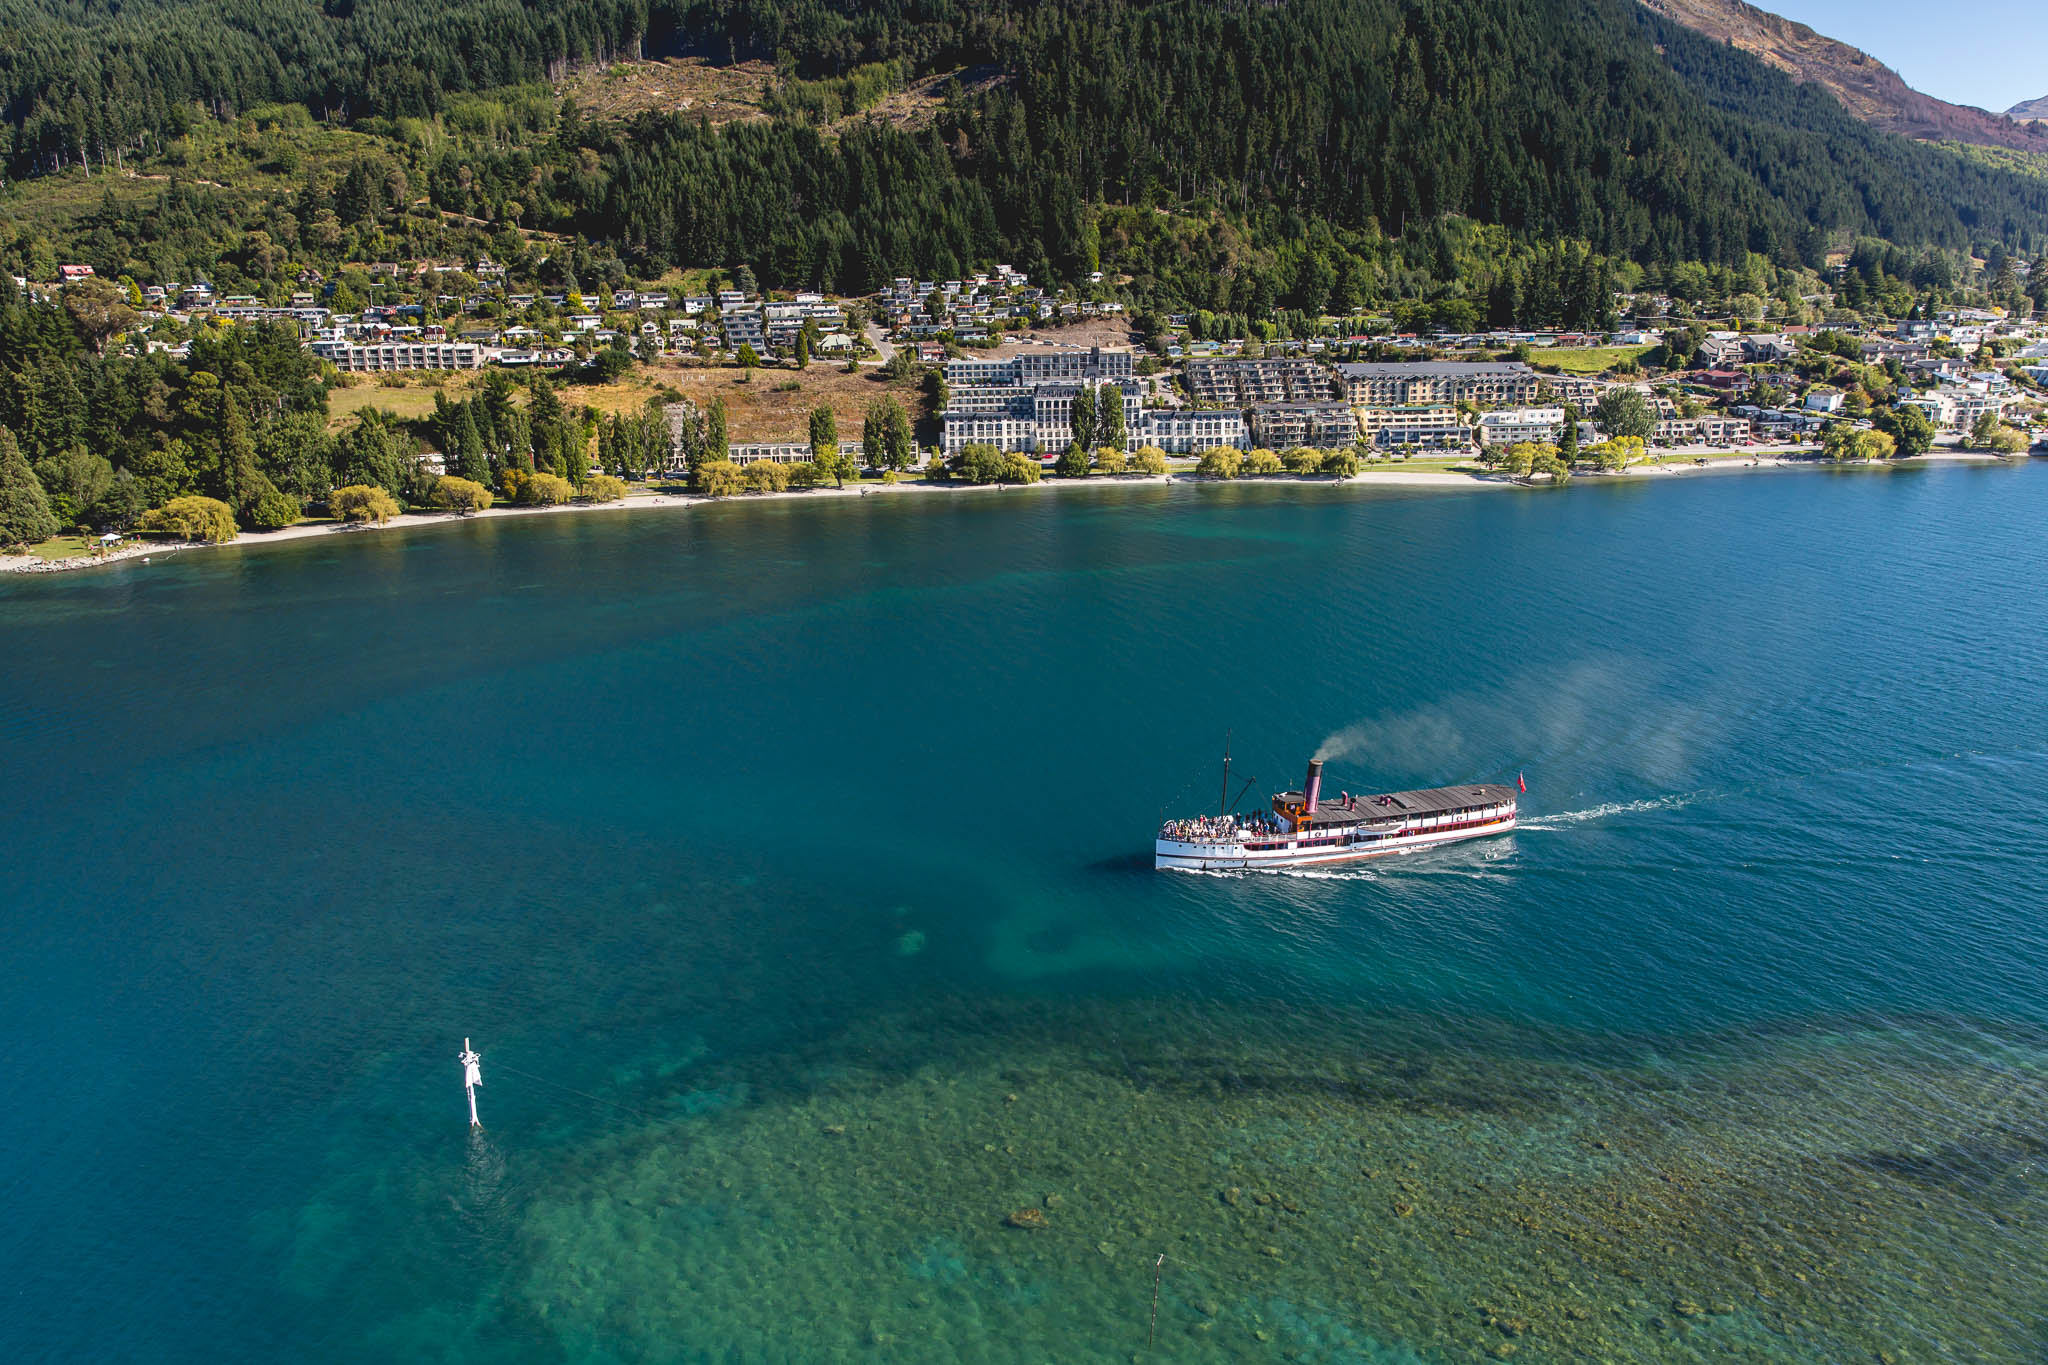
0, 467, 2048, 1361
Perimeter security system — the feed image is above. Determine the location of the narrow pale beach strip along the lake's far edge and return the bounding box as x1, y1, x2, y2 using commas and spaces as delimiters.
0, 450, 2025, 573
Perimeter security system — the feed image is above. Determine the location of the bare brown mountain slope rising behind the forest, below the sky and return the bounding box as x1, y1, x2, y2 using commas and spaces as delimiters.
1642, 0, 2048, 151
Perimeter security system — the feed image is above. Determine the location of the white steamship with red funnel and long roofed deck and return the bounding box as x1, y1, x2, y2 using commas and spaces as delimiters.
1153, 759, 1516, 872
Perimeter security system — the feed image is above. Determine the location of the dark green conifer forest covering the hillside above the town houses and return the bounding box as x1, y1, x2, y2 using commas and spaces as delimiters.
0, 0, 2048, 296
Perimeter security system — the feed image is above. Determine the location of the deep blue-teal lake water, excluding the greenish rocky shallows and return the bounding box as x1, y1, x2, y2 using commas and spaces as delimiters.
0, 465, 2048, 1361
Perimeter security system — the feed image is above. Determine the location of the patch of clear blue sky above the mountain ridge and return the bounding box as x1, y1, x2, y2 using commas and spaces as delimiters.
1749, 0, 2048, 113
